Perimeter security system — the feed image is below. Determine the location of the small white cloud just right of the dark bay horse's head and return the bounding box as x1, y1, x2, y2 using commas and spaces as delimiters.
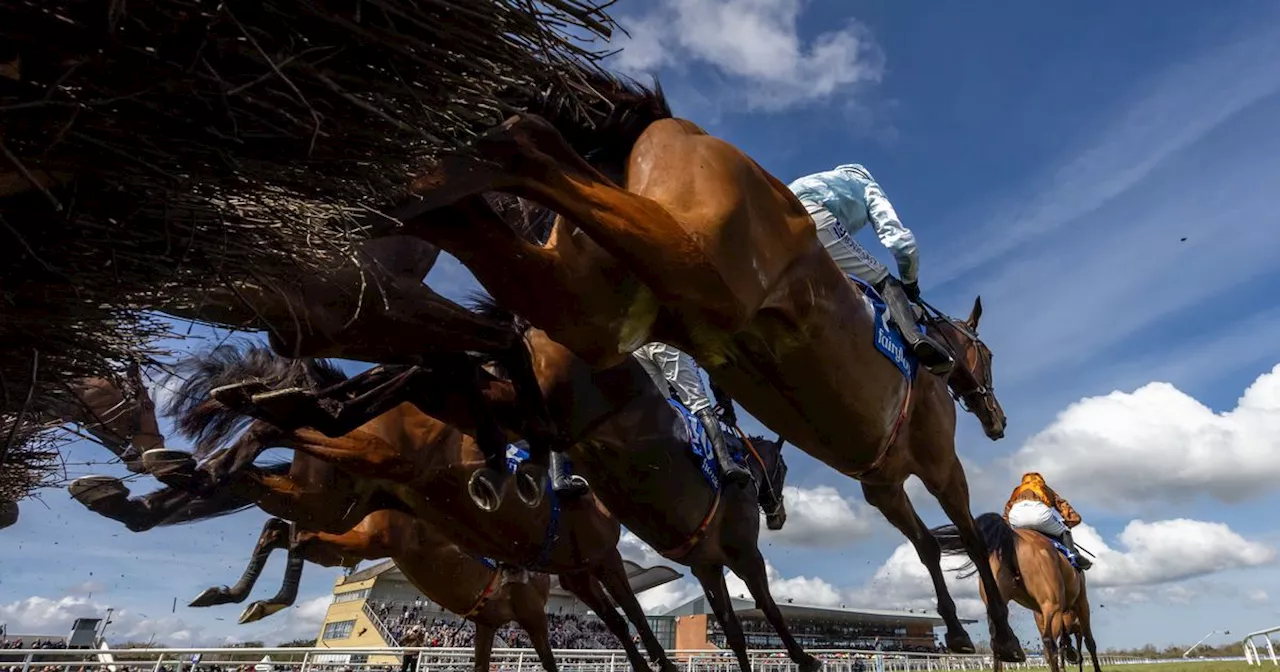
760, 485, 876, 548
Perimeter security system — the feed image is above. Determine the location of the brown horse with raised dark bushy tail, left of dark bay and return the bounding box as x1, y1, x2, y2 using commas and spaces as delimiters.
167, 346, 675, 672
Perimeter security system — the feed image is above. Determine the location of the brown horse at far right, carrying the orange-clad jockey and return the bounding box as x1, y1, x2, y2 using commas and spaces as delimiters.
932, 513, 1102, 672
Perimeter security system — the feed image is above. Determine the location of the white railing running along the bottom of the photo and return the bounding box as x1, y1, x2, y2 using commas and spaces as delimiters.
0, 646, 1158, 672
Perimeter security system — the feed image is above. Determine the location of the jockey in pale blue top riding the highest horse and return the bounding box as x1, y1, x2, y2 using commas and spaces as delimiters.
787, 164, 954, 375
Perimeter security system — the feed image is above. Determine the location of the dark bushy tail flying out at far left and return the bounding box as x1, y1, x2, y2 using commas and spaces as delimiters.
165, 343, 347, 457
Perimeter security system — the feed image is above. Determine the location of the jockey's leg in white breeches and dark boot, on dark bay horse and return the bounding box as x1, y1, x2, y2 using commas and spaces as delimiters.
631, 343, 751, 484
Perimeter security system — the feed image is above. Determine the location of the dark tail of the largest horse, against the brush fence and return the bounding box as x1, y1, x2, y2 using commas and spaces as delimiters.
511, 69, 672, 183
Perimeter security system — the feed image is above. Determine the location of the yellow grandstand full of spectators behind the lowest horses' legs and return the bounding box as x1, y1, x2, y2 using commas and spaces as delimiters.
316, 561, 682, 664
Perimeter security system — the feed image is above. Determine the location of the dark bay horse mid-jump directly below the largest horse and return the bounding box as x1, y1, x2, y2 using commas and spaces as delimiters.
204, 302, 820, 671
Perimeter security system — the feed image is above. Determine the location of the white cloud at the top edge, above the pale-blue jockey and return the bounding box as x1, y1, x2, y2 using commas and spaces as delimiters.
616, 0, 884, 110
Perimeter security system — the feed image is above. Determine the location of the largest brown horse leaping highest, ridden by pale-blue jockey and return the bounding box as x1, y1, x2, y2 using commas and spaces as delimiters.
396, 72, 1025, 662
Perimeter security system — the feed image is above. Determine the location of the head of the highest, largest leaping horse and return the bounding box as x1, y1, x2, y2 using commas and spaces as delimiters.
933, 297, 1006, 440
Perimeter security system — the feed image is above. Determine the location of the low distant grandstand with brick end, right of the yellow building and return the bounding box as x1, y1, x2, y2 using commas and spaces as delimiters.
666, 596, 977, 653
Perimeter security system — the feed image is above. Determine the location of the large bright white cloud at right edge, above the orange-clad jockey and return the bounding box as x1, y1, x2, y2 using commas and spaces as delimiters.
1011, 365, 1280, 509
